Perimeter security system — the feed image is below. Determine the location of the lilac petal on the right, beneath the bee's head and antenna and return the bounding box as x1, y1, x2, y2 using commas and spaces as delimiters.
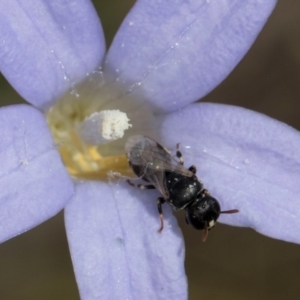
162, 103, 300, 243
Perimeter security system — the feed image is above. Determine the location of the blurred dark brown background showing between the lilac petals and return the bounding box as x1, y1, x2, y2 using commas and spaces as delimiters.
0, 0, 300, 300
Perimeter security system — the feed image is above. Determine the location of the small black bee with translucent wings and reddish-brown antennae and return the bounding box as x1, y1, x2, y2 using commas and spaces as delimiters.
125, 135, 239, 242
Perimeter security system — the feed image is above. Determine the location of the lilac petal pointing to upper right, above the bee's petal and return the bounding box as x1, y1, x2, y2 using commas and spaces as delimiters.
105, 0, 276, 111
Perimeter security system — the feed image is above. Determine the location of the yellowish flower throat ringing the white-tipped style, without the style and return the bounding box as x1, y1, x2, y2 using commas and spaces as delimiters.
46, 73, 154, 180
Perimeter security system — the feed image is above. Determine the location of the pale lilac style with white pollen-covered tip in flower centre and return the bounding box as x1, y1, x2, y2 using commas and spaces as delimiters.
77, 110, 132, 145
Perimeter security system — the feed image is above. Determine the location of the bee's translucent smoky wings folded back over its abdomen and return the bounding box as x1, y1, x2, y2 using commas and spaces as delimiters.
125, 135, 194, 198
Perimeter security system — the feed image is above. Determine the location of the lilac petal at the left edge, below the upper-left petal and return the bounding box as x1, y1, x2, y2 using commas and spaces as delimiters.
0, 105, 73, 242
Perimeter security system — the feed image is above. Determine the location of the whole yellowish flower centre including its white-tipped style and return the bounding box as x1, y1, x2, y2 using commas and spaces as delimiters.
46, 72, 153, 180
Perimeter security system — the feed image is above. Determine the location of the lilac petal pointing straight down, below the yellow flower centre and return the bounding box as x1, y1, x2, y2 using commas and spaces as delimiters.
65, 182, 187, 300
